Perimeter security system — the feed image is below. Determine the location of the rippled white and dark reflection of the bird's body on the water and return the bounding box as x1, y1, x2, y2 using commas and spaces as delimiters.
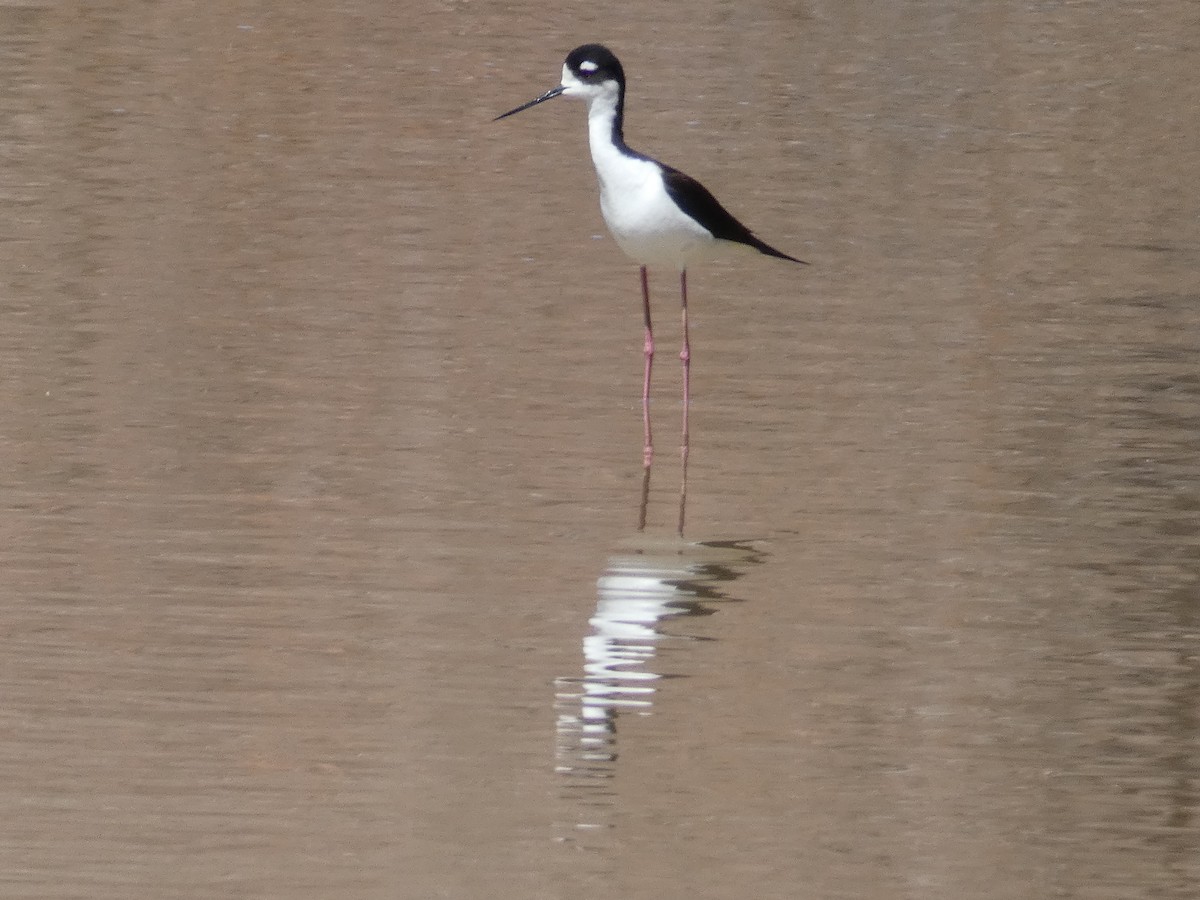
556, 535, 764, 840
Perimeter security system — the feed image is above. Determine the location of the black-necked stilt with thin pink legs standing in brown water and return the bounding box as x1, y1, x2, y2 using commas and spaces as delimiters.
496, 43, 805, 466
